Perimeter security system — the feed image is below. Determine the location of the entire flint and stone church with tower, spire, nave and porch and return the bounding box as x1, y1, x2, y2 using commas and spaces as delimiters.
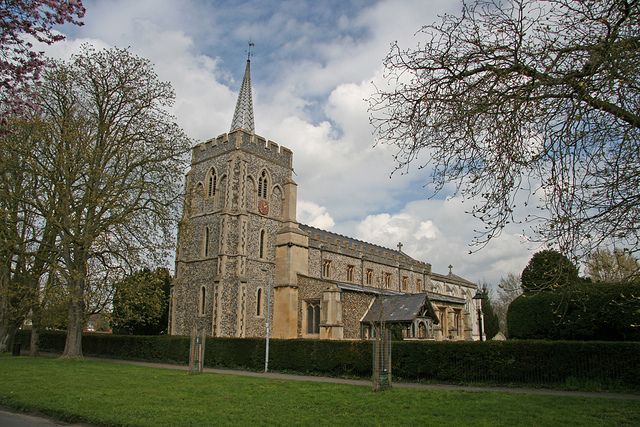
169, 59, 483, 340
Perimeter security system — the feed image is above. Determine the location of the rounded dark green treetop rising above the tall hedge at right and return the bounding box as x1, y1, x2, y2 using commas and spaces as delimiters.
522, 249, 578, 293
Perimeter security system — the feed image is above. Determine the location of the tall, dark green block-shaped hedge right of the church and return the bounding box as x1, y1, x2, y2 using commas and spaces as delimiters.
507, 283, 640, 341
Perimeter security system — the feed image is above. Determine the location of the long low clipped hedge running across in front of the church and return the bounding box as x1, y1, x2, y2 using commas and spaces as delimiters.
13, 331, 640, 389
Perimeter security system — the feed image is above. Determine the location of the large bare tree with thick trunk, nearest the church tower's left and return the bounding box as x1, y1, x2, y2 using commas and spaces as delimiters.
24, 46, 191, 357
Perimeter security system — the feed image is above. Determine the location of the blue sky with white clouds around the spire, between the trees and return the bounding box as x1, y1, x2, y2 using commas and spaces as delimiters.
46, 0, 537, 285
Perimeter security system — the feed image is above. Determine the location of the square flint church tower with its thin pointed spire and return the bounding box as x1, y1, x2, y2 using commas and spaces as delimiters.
169, 58, 308, 338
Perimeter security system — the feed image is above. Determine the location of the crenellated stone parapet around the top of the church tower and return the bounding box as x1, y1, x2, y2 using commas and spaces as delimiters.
191, 129, 293, 168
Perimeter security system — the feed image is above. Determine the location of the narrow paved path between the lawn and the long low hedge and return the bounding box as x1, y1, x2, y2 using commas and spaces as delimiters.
86, 357, 640, 401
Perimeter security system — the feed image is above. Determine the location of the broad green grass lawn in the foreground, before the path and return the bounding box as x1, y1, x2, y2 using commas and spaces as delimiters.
0, 356, 640, 426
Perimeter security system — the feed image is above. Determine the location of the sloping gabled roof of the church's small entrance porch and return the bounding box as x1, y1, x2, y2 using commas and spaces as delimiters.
361, 294, 438, 324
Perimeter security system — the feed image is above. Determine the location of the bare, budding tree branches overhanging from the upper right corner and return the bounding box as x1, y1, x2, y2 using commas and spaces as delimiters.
370, 0, 640, 255
